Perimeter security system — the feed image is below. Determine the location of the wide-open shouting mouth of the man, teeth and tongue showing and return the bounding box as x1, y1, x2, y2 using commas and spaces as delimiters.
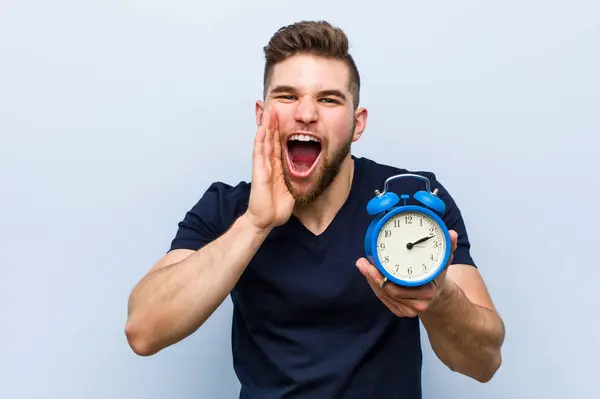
287, 134, 321, 177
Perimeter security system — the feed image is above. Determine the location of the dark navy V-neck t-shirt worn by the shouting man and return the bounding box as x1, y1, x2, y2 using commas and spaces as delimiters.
171, 157, 475, 399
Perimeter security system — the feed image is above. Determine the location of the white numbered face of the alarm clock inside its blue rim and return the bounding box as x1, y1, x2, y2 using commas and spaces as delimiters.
377, 212, 448, 281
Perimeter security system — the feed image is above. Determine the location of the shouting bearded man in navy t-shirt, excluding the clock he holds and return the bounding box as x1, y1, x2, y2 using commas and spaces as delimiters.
126, 22, 504, 399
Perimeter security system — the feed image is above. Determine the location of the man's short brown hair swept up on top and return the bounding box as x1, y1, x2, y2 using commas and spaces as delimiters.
263, 21, 360, 108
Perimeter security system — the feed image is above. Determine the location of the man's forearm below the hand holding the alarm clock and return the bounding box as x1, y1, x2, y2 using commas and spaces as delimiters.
420, 279, 504, 382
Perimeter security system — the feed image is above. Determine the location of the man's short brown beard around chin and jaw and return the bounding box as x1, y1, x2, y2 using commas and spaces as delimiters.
281, 130, 354, 205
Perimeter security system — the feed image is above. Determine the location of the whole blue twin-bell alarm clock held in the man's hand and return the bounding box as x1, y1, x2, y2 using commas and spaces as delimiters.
365, 173, 452, 287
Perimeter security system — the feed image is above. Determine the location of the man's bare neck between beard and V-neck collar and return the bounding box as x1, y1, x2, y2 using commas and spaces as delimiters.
294, 154, 354, 234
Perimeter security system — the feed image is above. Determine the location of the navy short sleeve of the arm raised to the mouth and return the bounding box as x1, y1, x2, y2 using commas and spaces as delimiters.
169, 182, 250, 251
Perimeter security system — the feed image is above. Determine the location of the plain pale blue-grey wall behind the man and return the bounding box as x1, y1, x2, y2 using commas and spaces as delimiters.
0, 0, 600, 399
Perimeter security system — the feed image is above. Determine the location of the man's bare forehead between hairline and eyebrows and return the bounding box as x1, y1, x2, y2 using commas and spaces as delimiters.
269, 55, 349, 92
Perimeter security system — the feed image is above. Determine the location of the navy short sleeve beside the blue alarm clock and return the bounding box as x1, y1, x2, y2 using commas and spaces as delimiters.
429, 173, 477, 267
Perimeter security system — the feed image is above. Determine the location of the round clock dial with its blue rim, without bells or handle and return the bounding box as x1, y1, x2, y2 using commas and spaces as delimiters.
373, 206, 450, 286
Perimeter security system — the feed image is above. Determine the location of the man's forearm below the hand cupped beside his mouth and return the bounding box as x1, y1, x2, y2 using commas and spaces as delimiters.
126, 215, 268, 355
